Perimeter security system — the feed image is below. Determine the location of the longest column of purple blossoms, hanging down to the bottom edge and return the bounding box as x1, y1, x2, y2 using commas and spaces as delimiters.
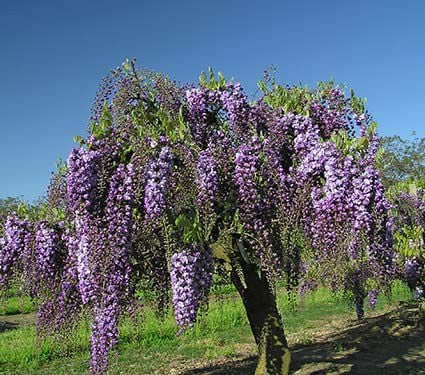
90, 164, 134, 374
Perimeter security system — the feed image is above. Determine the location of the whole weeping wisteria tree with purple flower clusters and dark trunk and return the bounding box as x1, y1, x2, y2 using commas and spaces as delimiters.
0, 62, 394, 374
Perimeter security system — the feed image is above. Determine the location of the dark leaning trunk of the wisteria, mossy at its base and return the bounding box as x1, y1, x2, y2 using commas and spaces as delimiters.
231, 263, 291, 375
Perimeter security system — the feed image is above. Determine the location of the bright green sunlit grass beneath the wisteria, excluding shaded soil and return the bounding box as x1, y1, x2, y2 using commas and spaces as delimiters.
0, 283, 410, 375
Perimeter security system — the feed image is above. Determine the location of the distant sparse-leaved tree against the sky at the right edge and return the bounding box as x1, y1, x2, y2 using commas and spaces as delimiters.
378, 135, 425, 187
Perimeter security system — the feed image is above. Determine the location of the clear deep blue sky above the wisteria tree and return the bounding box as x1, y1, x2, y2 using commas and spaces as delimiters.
0, 0, 425, 200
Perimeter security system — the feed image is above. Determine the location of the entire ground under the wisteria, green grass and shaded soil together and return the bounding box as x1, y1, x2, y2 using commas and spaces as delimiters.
0, 290, 425, 375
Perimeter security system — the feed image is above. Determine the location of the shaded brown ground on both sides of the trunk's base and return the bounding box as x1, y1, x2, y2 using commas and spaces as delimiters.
184, 304, 425, 375
